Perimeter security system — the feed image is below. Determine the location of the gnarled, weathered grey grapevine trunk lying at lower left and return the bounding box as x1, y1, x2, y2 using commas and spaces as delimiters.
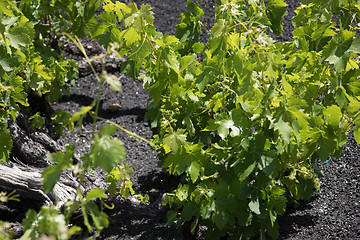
0, 114, 78, 208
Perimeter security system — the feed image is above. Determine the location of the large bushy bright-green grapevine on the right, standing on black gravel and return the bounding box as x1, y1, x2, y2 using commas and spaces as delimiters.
98, 0, 360, 239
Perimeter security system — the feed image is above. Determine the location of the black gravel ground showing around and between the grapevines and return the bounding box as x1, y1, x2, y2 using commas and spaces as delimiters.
47, 0, 360, 240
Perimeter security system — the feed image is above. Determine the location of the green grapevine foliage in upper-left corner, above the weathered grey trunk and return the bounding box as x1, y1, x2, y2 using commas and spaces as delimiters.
0, 0, 77, 161
